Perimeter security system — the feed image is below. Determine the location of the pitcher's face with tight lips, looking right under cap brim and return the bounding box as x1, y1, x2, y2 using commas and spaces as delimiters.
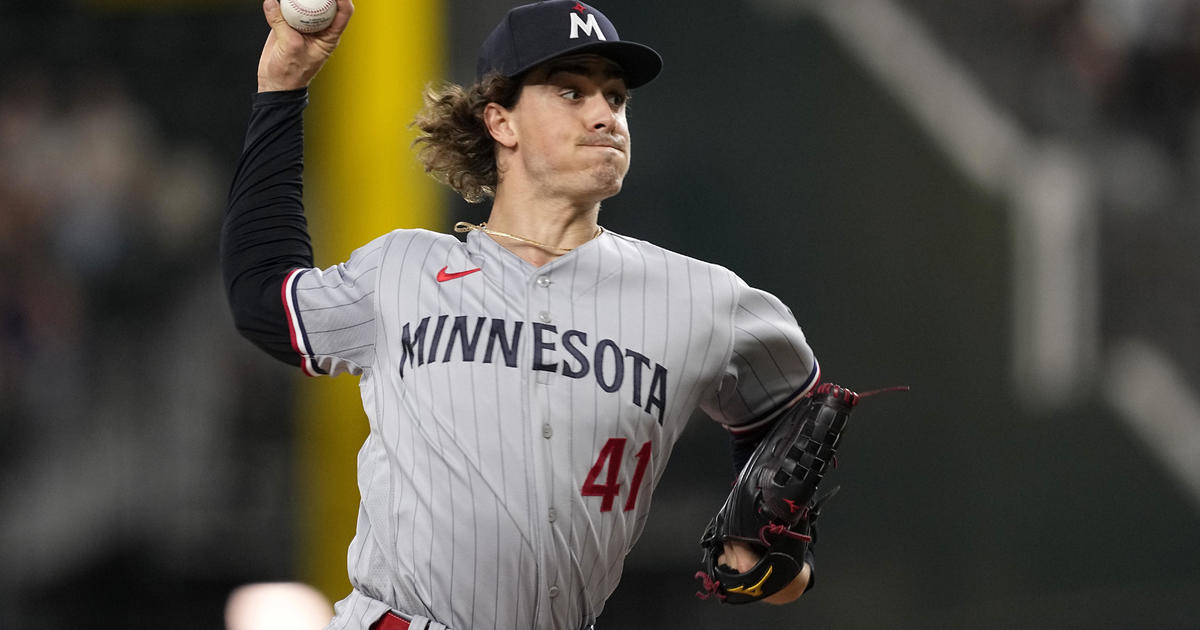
512, 55, 630, 202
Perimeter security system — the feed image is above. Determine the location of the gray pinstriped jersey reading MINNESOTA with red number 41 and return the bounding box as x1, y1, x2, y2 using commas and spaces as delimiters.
284, 230, 818, 630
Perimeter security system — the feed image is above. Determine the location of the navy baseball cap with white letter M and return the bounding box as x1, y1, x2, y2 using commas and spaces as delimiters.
475, 0, 662, 88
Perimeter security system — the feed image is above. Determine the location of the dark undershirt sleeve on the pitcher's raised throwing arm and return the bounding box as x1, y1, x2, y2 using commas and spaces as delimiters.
221, 89, 313, 365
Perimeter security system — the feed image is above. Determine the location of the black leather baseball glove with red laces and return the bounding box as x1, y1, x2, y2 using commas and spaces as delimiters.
696, 383, 859, 604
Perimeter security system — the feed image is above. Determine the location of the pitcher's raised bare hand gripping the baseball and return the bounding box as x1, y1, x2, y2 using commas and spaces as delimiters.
258, 0, 354, 92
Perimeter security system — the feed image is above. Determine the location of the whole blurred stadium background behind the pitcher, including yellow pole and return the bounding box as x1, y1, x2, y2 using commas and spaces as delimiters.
0, 0, 1200, 630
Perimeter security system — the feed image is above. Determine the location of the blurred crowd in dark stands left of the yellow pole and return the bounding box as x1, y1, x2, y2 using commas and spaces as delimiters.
0, 17, 292, 628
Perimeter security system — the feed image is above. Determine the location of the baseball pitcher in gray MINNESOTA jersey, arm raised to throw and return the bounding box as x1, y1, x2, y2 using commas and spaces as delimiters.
221, 0, 856, 630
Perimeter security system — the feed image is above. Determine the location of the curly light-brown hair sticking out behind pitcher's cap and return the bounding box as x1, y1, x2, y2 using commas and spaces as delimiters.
413, 73, 521, 203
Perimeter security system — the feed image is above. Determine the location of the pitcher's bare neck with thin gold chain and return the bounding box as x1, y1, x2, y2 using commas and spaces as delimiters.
487, 191, 600, 266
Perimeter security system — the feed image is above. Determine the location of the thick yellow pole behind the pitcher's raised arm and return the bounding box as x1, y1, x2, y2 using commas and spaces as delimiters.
296, 0, 444, 601
